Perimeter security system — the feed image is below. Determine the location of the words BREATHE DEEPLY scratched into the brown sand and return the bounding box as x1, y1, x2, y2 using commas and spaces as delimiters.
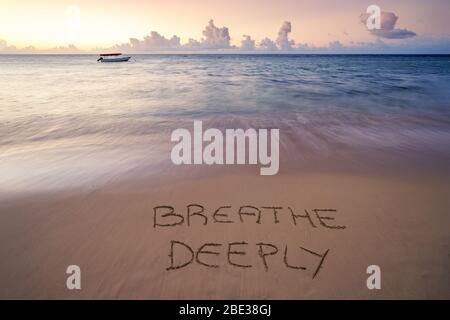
153, 204, 346, 278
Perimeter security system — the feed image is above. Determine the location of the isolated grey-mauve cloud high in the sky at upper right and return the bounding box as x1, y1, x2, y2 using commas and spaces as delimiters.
360, 12, 417, 39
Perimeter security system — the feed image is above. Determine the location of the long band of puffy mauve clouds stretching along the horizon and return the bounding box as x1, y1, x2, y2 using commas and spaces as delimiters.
0, 17, 450, 54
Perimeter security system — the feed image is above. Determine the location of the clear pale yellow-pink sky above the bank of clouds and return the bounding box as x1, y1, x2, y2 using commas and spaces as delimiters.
0, 0, 450, 50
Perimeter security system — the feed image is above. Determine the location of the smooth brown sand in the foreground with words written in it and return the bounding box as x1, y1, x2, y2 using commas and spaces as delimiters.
0, 170, 450, 299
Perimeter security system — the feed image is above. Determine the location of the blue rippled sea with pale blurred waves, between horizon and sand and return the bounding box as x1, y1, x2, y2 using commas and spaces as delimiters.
0, 54, 450, 193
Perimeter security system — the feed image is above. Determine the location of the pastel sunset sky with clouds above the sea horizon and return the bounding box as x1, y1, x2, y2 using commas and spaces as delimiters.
0, 0, 450, 53
